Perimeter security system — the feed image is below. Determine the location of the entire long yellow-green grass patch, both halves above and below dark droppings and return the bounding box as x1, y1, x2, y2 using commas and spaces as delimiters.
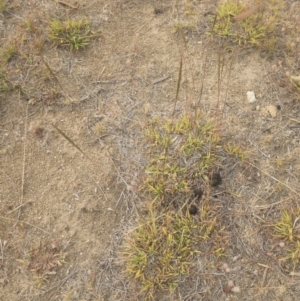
124, 112, 227, 299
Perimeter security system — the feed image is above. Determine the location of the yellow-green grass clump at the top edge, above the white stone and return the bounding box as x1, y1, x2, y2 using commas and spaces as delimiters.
213, 0, 284, 52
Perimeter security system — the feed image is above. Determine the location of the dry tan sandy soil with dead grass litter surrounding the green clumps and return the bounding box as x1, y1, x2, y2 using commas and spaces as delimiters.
0, 0, 300, 301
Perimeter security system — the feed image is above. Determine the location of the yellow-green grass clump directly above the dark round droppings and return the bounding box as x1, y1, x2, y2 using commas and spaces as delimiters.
145, 114, 219, 205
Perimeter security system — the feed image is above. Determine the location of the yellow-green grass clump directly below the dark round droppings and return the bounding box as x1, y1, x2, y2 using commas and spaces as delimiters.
124, 206, 223, 299
